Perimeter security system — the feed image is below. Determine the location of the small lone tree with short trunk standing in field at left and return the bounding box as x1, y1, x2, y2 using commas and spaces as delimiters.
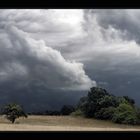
2, 103, 27, 123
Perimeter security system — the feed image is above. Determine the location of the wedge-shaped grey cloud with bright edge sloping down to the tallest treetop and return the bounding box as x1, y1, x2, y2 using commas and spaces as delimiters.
0, 25, 96, 90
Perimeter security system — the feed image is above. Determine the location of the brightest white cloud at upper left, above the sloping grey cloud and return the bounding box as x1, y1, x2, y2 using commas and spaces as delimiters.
0, 9, 83, 45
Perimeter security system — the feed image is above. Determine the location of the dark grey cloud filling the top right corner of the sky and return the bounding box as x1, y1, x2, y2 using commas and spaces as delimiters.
86, 9, 140, 43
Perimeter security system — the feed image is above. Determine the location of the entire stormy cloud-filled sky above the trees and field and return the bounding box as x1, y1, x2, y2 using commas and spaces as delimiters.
0, 9, 140, 110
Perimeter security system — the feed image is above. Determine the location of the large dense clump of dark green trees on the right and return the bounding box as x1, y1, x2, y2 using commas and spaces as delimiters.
76, 87, 140, 124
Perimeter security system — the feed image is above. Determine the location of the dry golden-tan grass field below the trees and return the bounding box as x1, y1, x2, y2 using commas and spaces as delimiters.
0, 116, 140, 131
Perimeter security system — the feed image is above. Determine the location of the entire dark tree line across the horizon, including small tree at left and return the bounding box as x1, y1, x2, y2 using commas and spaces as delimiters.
1, 87, 140, 125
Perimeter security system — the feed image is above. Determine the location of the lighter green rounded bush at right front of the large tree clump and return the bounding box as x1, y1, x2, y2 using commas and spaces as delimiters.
112, 103, 139, 125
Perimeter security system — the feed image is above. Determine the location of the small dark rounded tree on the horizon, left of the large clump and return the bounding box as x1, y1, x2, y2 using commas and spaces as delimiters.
60, 105, 75, 115
